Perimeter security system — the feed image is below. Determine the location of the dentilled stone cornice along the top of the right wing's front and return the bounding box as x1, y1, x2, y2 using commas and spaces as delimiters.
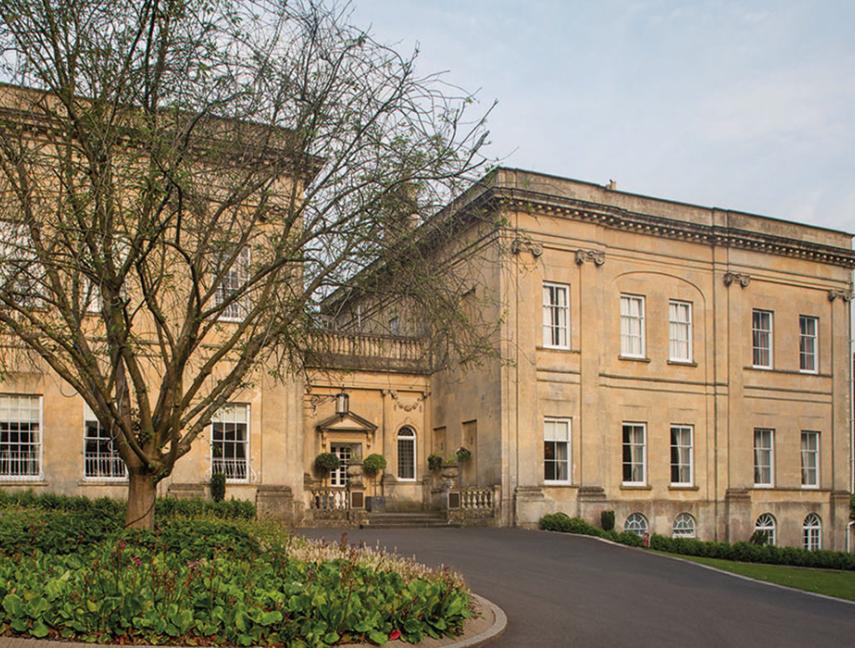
489, 187, 855, 269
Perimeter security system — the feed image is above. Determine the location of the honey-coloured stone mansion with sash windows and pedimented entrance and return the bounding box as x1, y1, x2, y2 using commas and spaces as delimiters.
0, 169, 855, 549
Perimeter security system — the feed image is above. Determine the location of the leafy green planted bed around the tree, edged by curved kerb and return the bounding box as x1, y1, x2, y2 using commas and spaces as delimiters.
0, 494, 471, 646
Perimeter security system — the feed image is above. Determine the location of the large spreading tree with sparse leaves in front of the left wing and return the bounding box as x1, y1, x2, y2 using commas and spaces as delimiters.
0, 0, 494, 527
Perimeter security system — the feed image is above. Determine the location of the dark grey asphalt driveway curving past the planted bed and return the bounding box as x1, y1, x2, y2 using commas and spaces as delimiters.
301, 528, 855, 648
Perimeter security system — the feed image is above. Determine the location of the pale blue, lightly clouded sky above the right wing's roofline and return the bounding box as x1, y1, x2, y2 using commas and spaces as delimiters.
352, 0, 855, 232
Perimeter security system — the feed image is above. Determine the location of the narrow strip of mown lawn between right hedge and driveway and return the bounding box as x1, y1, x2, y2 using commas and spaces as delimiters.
656, 551, 855, 601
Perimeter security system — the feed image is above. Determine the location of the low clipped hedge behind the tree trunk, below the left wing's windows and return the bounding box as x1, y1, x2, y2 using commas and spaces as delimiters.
0, 490, 256, 521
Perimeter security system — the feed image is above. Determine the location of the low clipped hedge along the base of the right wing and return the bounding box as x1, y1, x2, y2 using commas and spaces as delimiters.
540, 513, 855, 570
